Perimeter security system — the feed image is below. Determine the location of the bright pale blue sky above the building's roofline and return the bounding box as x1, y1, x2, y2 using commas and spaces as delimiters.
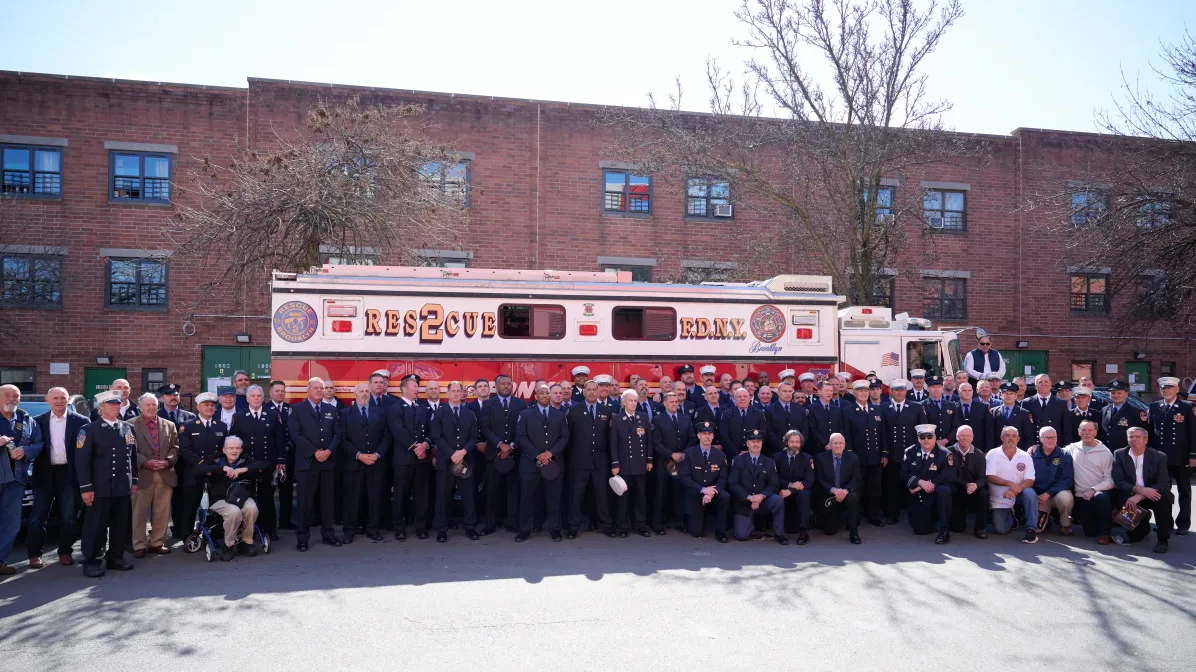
0, 0, 1196, 133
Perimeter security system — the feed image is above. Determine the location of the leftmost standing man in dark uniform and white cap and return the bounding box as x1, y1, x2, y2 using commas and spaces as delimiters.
74, 391, 136, 579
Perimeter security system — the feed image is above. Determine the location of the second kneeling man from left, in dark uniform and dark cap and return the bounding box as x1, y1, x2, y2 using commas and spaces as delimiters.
727, 429, 789, 546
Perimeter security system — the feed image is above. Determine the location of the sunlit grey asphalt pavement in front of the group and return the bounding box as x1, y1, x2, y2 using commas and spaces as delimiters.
0, 524, 1196, 672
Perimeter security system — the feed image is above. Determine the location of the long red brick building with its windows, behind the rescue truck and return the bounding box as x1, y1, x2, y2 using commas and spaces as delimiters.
0, 72, 1196, 393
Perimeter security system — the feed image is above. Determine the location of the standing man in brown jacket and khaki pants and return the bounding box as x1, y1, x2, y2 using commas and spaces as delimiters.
133, 392, 178, 558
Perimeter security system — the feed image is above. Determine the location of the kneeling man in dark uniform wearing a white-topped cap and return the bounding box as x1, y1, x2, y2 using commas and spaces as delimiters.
902, 423, 956, 544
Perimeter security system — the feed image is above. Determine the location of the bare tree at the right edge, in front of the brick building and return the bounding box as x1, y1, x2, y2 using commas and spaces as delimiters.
1031, 33, 1196, 336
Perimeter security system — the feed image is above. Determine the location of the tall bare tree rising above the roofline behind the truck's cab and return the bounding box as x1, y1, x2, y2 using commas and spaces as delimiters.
602, 0, 989, 297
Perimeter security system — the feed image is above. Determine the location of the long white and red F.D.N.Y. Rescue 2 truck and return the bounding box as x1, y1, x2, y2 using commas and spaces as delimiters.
271, 264, 962, 399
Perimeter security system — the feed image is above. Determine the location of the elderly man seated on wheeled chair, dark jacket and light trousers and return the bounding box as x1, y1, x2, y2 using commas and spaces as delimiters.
206, 436, 264, 562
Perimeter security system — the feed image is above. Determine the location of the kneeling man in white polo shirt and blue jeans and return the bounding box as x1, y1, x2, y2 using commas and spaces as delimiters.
984, 427, 1038, 544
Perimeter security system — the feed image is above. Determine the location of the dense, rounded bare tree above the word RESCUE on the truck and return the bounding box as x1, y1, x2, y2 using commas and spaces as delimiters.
171, 98, 469, 313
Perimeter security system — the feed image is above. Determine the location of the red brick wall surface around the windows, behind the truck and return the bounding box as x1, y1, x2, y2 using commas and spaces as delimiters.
0, 73, 1194, 392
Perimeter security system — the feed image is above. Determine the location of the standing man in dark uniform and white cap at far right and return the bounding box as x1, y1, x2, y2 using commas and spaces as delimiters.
1149, 377, 1196, 534
